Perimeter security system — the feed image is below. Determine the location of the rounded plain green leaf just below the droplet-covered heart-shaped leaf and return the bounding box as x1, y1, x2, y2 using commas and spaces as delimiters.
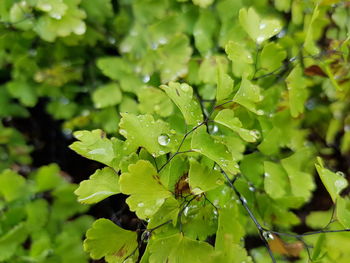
260, 42, 287, 72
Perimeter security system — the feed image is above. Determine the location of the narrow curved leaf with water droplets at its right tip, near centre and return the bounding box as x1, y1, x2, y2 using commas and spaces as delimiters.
215, 109, 259, 142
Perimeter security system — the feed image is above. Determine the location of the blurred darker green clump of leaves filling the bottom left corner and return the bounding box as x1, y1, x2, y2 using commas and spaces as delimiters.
0, 164, 93, 263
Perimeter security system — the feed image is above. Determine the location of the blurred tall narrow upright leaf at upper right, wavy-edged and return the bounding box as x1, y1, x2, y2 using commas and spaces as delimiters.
286, 66, 308, 117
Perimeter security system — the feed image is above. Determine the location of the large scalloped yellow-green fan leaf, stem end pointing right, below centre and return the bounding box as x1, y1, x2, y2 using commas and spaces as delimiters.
119, 160, 172, 219
